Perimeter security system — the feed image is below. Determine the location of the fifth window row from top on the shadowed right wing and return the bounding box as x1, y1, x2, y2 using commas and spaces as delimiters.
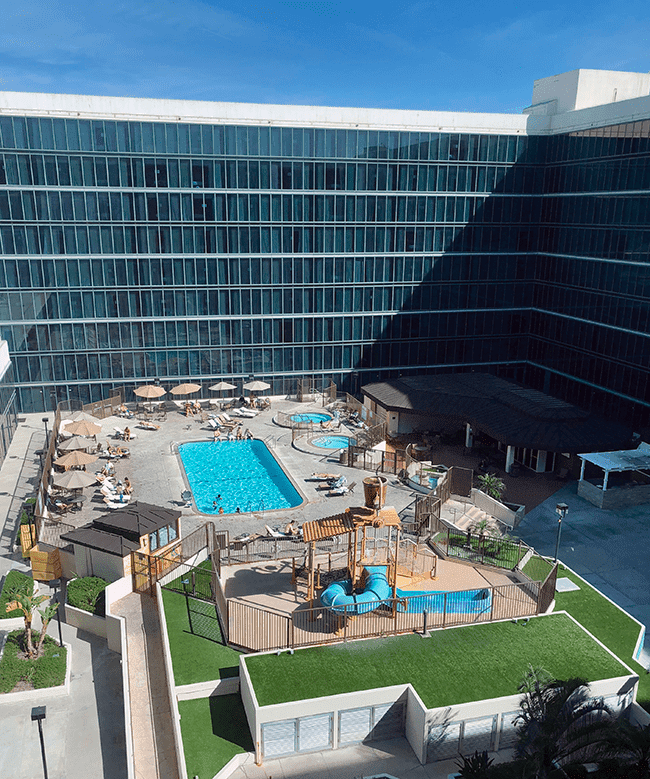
535, 256, 650, 300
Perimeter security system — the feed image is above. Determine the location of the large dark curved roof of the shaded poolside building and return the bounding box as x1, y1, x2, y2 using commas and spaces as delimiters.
361, 373, 632, 453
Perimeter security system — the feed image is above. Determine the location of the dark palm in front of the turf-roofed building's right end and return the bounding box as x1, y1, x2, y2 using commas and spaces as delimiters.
515, 671, 612, 779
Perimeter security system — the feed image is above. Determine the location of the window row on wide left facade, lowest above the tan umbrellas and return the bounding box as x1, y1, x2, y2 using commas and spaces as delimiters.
10, 336, 526, 386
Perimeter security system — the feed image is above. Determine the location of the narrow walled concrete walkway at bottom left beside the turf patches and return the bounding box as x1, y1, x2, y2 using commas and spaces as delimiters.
111, 593, 178, 779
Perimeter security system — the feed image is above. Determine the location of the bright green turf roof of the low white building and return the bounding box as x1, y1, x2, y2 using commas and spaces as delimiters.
245, 614, 627, 708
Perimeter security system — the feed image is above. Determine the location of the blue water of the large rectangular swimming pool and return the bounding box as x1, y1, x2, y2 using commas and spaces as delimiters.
178, 440, 302, 514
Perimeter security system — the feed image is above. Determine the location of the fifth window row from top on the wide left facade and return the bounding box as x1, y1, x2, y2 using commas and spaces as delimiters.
0, 254, 535, 290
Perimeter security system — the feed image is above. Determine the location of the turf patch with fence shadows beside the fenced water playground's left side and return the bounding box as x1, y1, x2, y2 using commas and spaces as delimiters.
162, 589, 240, 685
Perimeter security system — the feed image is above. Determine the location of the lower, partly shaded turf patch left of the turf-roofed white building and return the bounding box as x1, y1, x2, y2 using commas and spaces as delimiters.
178, 694, 253, 779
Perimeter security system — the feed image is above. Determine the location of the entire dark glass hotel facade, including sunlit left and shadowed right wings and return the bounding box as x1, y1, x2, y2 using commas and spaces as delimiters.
0, 84, 650, 430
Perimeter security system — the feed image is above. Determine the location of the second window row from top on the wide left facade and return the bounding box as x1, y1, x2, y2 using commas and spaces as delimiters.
0, 154, 543, 193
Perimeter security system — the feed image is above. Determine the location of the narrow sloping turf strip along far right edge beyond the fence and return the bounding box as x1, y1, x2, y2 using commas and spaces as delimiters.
555, 566, 650, 710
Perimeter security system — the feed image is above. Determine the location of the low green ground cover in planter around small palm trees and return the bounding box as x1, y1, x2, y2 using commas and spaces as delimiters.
0, 630, 67, 692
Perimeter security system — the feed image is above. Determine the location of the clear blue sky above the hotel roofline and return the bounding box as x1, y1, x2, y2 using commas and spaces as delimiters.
0, 0, 650, 113
